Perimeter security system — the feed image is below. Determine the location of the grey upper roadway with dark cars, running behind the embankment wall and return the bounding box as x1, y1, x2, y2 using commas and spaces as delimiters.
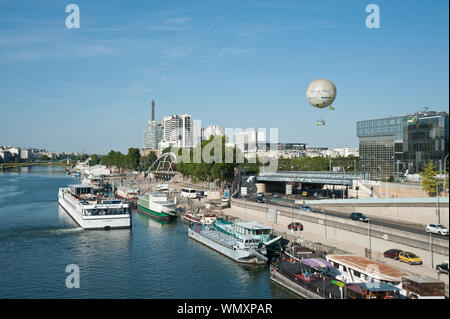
241, 194, 448, 239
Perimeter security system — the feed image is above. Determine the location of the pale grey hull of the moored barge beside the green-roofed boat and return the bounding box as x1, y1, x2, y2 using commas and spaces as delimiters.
188, 228, 266, 264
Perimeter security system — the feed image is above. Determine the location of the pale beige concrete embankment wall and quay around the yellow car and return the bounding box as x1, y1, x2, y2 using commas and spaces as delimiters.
224, 199, 449, 296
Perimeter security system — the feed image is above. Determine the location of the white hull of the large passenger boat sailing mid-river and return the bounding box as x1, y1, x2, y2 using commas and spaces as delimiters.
58, 193, 131, 229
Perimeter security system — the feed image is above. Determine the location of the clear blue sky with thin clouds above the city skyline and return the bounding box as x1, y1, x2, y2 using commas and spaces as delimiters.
0, 0, 449, 154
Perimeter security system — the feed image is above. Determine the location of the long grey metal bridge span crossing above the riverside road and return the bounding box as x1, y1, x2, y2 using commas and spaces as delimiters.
256, 172, 359, 187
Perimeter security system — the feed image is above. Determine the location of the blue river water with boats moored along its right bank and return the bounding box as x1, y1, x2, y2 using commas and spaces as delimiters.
0, 167, 296, 299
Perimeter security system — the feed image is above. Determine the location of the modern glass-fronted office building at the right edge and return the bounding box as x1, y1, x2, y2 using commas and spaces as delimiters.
356, 111, 448, 179
